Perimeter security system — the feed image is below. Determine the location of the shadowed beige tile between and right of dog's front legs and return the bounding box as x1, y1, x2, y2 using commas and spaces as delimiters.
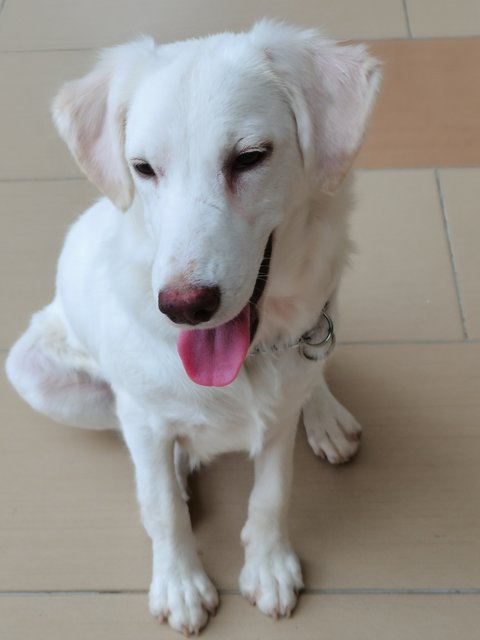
199, 345, 480, 589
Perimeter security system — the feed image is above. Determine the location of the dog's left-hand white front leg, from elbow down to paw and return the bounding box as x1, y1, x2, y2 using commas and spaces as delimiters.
118, 398, 218, 635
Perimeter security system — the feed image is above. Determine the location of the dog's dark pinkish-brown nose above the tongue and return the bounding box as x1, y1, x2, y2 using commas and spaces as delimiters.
158, 286, 221, 326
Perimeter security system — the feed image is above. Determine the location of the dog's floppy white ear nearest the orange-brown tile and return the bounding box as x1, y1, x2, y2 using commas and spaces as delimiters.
252, 20, 381, 193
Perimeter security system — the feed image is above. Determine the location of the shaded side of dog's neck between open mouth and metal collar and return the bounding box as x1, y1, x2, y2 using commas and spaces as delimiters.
254, 182, 351, 349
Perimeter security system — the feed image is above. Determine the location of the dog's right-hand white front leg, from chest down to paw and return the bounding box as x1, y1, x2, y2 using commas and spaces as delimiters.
240, 416, 303, 618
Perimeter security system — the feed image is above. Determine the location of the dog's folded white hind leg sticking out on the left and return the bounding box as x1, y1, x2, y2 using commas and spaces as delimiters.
5, 301, 118, 429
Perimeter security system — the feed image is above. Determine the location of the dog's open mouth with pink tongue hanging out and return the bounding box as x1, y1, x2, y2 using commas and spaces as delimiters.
177, 233, 273, 387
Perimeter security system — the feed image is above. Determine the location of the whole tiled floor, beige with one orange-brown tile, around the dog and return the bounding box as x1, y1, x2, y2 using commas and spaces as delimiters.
0, 0, 480, 640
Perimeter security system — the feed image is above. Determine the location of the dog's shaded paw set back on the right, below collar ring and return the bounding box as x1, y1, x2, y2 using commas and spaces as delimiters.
303, 388, 362, 464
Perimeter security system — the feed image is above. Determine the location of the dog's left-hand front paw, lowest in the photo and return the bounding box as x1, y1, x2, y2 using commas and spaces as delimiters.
149, 566, 218, 636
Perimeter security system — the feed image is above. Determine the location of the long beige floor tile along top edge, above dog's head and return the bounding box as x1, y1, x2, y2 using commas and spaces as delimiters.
0, 0, 407, 51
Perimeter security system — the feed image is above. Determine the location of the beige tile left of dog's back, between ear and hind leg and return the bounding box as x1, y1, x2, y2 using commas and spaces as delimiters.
0, 180, 96, 348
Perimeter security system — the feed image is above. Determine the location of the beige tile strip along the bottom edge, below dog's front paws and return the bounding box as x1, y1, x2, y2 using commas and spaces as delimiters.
0, 595, 480, 640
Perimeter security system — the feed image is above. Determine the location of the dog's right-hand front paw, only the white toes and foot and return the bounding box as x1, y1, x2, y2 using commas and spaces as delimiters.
240, 543, 303, 619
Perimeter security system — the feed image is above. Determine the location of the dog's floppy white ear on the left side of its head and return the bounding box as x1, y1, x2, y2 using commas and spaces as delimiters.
52, 38, 155, 211
